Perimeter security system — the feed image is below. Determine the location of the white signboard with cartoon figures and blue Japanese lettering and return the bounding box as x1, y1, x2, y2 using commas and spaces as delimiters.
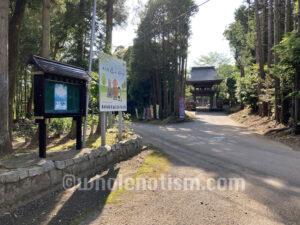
99, 53, 127, 112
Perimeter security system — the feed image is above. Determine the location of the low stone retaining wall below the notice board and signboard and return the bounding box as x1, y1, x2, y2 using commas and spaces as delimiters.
0, 137, 143, 207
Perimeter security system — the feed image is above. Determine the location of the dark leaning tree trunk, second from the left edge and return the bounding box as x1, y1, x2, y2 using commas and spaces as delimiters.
8, 0, 27, 140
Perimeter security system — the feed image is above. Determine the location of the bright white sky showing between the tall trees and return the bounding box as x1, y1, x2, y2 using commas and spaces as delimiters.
113, 0, 243, 68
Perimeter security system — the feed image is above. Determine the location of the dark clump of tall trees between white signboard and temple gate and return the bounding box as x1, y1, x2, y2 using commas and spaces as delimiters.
125, 0, 198, 118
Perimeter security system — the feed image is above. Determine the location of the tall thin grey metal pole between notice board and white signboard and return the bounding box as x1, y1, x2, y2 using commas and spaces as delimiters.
82, 0, 97, 147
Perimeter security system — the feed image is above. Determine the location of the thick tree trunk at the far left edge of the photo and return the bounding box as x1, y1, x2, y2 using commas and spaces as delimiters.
0, 0, 12, 155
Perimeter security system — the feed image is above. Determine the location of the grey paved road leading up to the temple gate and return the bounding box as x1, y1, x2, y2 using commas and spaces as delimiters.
133, 113, 300, 224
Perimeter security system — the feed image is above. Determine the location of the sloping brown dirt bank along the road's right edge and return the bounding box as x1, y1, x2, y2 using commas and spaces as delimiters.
230, 109, 300, 151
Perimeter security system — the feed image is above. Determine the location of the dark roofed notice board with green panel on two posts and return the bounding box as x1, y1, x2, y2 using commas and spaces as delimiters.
28, 55, 90, 158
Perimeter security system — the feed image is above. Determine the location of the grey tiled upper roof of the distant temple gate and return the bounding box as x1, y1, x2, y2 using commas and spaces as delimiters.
187, 66, 222, 84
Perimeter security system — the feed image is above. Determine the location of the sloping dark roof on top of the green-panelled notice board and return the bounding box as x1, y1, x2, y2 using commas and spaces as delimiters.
28, 55, 90, 80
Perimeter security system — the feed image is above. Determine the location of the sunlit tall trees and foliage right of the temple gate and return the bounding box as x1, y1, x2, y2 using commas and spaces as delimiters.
224, 0, 300, 133
